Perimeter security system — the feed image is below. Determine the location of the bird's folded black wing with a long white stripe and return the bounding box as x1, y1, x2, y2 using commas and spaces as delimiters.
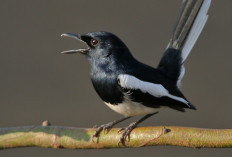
118, 74, 194, 110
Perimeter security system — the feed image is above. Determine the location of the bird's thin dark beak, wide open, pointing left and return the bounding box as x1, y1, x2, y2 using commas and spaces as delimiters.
61, 33, 89, 54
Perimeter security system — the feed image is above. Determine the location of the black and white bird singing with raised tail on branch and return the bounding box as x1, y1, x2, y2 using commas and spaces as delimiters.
61, 0, 211, 145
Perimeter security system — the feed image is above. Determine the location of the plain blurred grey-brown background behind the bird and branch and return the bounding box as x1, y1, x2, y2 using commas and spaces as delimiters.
0, 0, 232, 157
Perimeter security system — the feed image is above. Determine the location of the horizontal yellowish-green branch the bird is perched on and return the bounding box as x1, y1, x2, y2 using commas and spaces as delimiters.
0, 126, 232, 149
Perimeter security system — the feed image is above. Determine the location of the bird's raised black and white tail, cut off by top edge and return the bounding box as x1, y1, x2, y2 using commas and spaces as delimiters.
158, 0, 211, 87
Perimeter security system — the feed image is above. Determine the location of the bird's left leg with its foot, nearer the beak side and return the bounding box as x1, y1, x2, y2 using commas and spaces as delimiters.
92, 117, 130, 139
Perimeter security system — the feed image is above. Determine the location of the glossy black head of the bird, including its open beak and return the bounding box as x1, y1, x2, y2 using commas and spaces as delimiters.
61, 31, 131, 60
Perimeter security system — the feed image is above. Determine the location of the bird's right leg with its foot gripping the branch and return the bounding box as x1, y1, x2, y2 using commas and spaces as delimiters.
118, 112, 158, 146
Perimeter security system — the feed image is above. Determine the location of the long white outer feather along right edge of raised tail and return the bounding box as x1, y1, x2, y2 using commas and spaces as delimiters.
182, 0, 211, 63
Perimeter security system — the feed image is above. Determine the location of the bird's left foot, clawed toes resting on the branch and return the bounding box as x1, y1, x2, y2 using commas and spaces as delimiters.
91, 122, 114, 142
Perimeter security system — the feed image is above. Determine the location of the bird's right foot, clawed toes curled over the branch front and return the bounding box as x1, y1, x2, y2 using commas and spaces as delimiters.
118, 122, 137, 147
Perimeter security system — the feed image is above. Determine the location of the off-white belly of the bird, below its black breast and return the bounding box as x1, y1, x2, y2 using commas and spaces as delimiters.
105, 99, 160, 116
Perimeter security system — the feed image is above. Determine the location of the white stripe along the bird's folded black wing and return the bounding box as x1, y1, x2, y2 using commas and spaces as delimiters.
118, 74, 188, 105
